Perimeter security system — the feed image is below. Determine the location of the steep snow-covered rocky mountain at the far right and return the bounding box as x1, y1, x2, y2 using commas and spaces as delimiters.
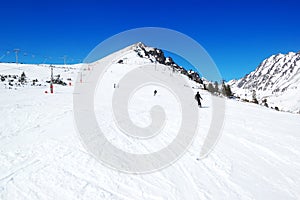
229, 52, 300, 113
